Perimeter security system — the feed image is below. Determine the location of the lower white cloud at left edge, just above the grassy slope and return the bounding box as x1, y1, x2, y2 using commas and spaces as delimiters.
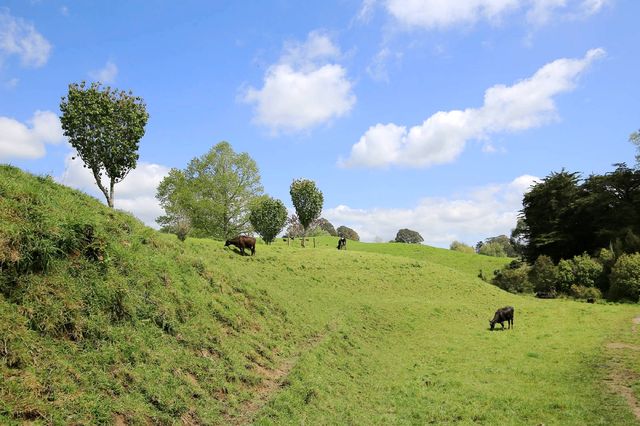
0, 111, 64, 160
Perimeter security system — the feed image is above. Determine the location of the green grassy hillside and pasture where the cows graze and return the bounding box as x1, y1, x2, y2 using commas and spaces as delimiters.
0, 166, 640, 424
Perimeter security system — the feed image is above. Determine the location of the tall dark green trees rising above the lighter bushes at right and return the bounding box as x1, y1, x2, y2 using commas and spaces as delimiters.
519, 163, 640, 262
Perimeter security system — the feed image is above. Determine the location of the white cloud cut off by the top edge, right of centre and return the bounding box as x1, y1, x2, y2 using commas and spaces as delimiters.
382, 0, 611, 30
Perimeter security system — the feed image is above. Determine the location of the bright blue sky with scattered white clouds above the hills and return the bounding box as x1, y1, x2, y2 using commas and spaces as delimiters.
0, 0, 640, 248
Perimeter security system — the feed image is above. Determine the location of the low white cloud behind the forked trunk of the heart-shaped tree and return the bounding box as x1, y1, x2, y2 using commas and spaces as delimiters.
58, 154, 169, 228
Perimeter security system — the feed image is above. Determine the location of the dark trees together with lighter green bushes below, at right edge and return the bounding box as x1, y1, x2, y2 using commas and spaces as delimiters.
493, 131, 640, 302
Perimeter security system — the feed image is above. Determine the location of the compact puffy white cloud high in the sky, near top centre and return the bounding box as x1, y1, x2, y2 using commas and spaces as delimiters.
240, 32, 356, 133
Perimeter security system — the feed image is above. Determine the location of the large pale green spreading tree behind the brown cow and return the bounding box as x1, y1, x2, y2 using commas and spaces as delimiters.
156, 142, 263, 240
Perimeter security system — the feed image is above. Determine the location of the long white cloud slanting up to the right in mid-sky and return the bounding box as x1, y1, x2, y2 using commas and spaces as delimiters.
338, 49, 605, 167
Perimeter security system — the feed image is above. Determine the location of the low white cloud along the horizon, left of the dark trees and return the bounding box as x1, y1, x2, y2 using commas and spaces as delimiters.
322, 175, 539, 248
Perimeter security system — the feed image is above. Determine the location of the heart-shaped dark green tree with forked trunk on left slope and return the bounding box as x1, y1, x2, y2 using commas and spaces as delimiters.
60, 82, 149, 207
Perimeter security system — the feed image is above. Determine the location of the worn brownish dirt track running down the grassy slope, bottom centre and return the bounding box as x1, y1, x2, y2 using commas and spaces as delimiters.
225, 330, 330, 425
